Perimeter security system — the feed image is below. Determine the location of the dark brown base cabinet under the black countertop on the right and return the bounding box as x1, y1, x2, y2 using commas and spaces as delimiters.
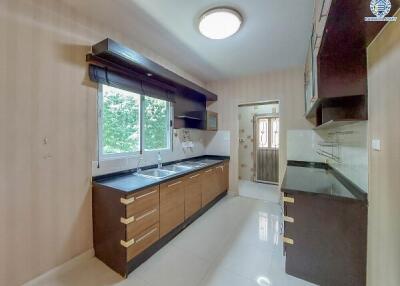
283, 193, 367, 286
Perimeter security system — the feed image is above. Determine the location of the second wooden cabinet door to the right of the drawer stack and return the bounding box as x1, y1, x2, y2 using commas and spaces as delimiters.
185, 172, 203, 219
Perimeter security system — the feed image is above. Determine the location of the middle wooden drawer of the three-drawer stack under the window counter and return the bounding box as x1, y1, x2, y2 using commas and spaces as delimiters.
126, 207, 160, 240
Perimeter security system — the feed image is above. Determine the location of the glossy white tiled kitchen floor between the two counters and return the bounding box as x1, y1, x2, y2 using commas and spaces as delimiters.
25, 197, 313, 286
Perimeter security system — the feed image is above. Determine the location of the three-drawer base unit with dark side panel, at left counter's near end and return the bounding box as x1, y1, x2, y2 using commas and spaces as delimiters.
93, 185, 159, 276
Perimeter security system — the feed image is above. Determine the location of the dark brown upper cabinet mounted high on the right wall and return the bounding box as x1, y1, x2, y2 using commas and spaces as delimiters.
305, 0, 399, 127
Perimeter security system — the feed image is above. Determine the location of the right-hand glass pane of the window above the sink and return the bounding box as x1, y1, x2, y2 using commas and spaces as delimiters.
143, 96, 170, 150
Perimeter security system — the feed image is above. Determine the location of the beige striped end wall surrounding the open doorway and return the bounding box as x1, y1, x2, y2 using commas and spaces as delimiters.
207, 67, 312, 193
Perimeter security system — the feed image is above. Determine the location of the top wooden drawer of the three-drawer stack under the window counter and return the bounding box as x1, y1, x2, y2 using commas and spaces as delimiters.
121, 186, 160, 218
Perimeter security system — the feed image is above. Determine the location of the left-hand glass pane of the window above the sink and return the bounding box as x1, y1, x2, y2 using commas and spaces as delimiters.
102, 85, 140, 155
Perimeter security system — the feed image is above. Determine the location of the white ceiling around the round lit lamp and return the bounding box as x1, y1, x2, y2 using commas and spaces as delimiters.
62, 0, 314, 82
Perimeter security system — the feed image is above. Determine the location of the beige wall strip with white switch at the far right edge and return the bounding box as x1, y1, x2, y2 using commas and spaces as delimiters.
367, 9, 400, 286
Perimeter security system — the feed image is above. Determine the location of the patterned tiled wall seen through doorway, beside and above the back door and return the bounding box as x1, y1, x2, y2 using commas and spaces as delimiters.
239, 104, 279, 181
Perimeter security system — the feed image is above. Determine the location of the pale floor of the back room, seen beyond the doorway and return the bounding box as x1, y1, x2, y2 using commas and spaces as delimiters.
239, 180, 280, 203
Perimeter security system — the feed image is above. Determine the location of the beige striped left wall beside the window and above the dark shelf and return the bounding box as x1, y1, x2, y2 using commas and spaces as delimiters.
0, 0, 203, 286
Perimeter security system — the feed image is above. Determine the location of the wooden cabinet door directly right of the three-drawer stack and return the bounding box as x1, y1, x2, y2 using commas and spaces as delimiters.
160, 178, 185, 237
